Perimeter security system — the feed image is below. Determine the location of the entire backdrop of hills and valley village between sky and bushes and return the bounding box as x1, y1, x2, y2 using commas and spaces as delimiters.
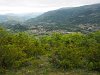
0, 3, 100, 35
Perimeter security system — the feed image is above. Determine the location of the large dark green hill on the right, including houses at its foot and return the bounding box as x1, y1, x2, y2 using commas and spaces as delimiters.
25, 4, 100, 32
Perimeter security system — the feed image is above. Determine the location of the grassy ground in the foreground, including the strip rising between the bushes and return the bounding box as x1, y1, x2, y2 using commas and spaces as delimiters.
0, 57, 100, 75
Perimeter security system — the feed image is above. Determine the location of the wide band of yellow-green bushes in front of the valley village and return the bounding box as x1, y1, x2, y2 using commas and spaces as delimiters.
0, 28, 100, 72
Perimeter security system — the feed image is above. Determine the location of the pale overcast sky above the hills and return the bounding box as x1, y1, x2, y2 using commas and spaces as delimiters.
0, 0, 100, 14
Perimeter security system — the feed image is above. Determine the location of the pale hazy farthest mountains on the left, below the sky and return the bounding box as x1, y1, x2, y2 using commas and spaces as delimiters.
0, 13, 42, 23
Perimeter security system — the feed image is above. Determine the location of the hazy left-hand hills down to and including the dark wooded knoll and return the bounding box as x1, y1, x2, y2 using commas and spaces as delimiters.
0, 13, 42, 31
